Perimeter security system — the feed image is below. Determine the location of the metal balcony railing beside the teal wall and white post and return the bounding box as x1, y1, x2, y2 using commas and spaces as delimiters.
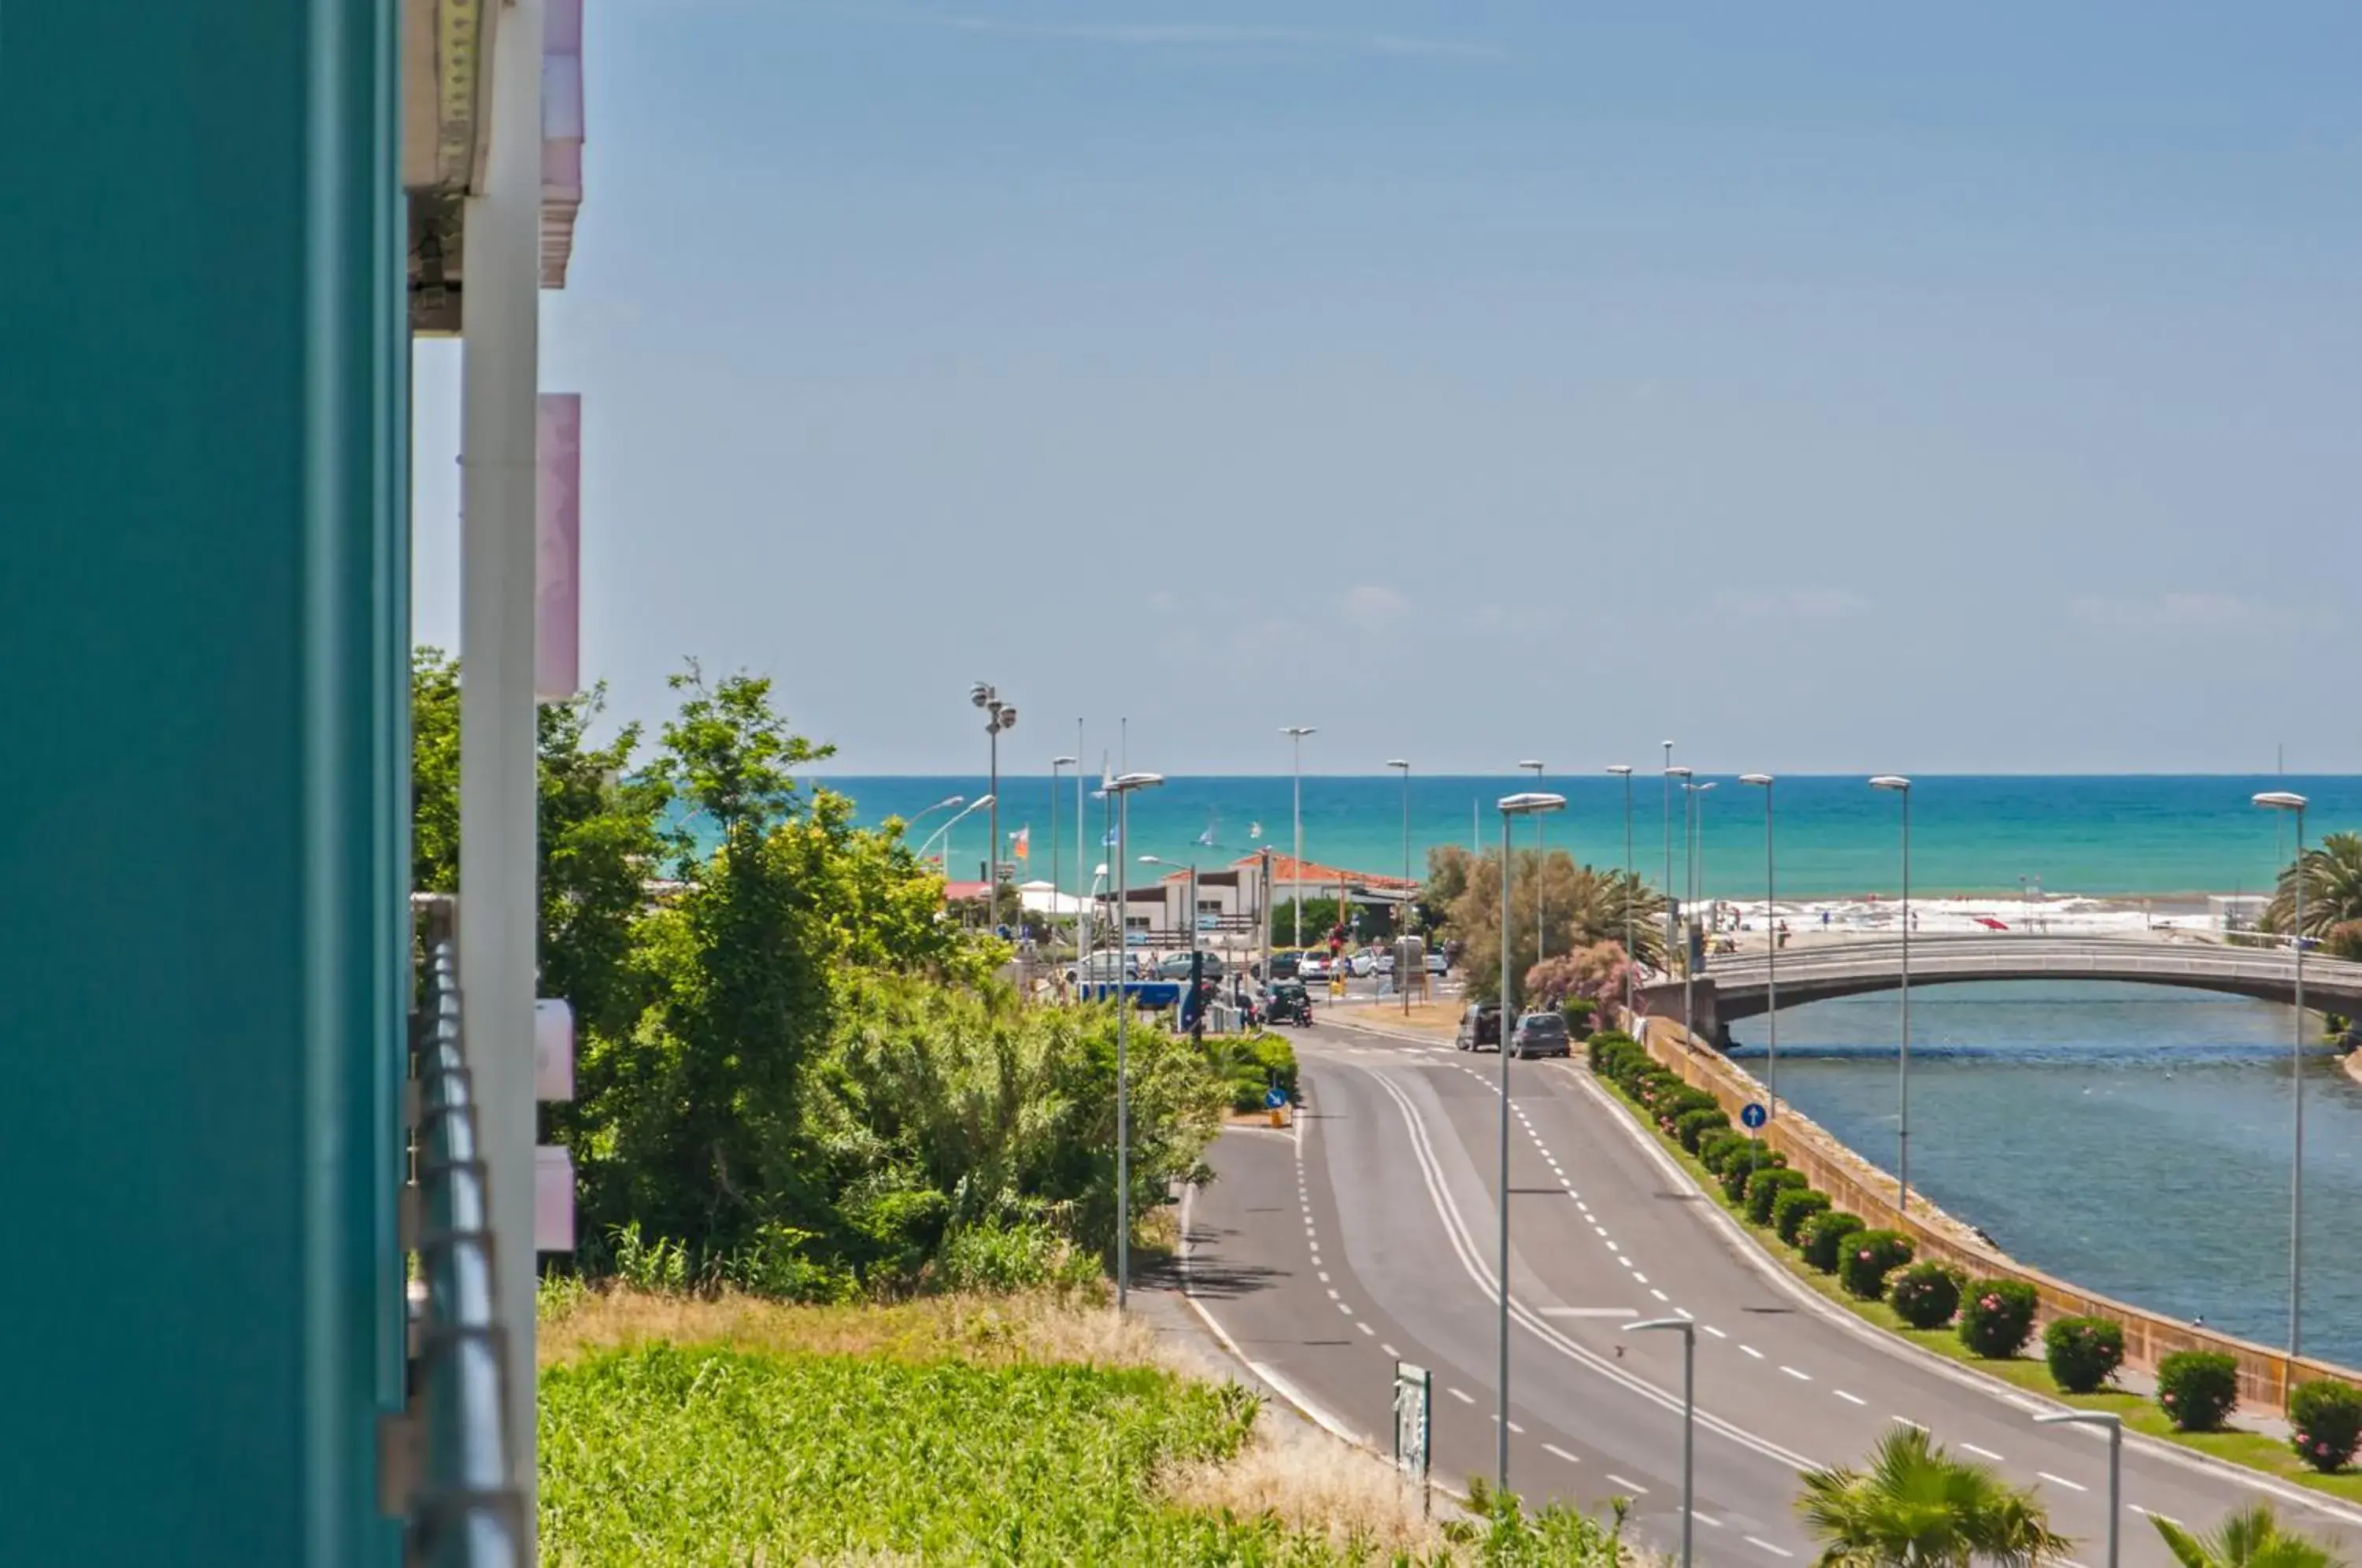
402, 897, 531, 1568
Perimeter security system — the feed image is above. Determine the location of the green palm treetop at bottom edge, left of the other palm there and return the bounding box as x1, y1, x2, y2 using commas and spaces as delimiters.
1795, 1426, 2074, 1568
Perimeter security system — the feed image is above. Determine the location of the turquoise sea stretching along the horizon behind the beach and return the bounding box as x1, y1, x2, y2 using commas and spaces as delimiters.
822, 772, 2362, 900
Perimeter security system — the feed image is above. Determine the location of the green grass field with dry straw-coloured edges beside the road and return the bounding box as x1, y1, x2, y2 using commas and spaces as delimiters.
541, 1292, 1639, 1568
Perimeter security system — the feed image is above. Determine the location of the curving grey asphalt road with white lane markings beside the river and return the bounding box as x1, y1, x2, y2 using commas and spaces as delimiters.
1186, 1025, 2362, 1568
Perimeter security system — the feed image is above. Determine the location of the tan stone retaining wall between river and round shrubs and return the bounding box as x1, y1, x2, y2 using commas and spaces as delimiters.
1642, 1018, 2362, 1410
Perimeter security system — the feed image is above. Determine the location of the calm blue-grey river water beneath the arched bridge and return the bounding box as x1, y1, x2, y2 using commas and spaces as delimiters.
1731, 982, 2362, 1367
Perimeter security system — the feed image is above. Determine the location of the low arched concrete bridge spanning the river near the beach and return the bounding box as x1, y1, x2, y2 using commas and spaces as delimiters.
1642, 933, 2362, 1039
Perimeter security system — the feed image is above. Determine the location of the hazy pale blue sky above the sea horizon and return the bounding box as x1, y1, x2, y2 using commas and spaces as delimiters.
416, 0, 2362, 772
